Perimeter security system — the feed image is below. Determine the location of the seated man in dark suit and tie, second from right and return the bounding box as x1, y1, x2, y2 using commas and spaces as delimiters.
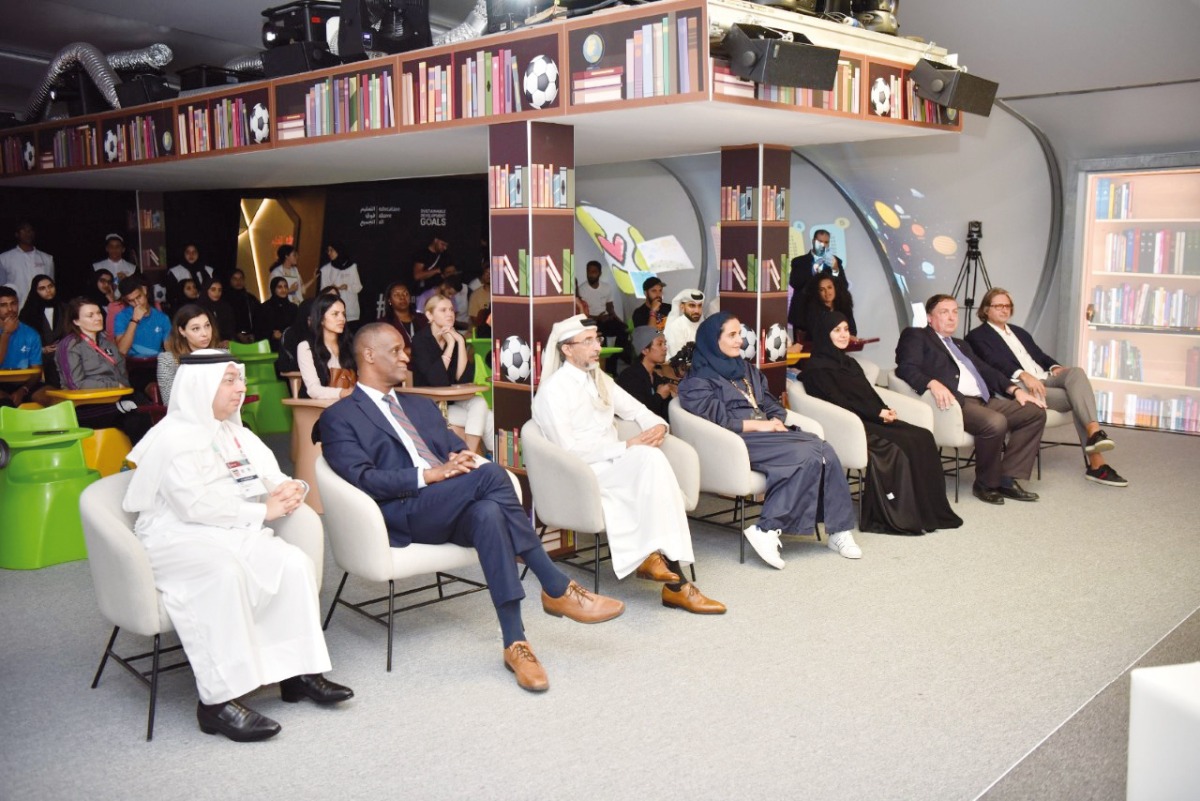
896, 295, 1046, 504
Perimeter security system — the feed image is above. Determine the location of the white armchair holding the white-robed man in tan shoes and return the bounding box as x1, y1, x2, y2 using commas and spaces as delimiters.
521, 420, 701, 592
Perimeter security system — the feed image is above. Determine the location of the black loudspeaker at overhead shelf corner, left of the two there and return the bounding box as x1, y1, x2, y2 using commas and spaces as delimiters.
721, 24, 841, 91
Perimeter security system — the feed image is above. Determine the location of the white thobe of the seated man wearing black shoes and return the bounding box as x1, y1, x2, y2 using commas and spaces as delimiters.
134, 430, 330, 704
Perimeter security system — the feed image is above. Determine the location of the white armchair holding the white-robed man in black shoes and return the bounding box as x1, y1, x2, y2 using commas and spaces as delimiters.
79, 471, 325, 740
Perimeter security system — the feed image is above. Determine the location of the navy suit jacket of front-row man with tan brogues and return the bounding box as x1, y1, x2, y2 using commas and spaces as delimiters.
320, 387, 468, 547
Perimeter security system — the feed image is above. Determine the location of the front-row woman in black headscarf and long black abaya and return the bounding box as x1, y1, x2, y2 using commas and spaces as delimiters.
800, 312, 962, 534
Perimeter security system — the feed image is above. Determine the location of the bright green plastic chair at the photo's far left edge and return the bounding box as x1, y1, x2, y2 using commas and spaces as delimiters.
0, 403, 100, 570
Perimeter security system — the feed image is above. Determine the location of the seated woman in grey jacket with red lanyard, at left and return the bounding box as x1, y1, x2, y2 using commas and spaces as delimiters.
54, 297, 150, 442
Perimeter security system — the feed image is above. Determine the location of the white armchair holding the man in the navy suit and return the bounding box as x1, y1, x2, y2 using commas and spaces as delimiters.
316, 456, 496, 671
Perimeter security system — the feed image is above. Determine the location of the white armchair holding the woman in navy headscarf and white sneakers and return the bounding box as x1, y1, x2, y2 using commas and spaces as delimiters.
671, 398, 824, 562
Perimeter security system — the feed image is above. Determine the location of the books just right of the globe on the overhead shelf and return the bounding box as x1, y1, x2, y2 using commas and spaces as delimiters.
624, 14, 701, 102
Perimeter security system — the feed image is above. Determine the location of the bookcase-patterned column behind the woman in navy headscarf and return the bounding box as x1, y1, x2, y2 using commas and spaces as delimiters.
720, 144, 791, 396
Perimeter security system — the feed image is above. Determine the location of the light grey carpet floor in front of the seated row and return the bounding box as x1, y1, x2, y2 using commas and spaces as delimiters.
0, 422, 1200, 800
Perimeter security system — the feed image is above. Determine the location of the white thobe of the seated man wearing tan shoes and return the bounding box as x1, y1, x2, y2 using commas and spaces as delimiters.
533, 363, 695, 578
